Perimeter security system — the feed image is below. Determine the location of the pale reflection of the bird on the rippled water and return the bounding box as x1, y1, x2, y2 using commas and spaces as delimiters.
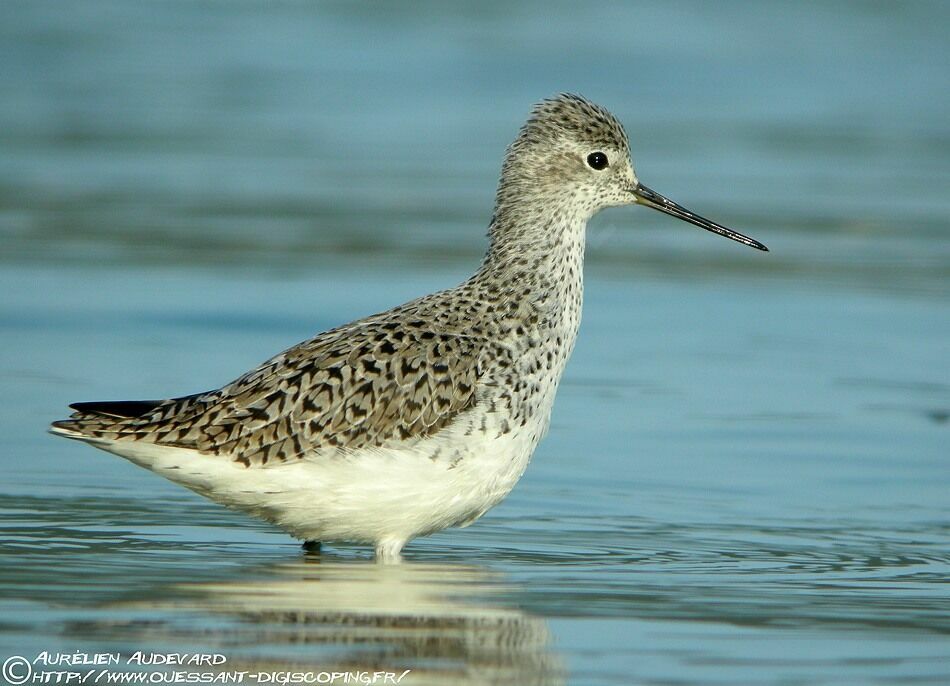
95, 557, 564, 686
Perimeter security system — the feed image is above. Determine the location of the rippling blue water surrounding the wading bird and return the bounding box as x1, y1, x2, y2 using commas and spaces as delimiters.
0, 2, 950, 685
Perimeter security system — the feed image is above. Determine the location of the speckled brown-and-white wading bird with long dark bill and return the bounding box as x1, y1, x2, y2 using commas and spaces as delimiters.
50, 93, 768, 563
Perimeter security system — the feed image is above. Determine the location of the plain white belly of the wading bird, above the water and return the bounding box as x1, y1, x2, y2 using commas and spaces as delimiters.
100, 420, 540, 543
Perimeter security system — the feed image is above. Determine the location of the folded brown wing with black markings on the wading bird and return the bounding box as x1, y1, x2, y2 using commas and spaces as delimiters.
59, 320, 482, 467
